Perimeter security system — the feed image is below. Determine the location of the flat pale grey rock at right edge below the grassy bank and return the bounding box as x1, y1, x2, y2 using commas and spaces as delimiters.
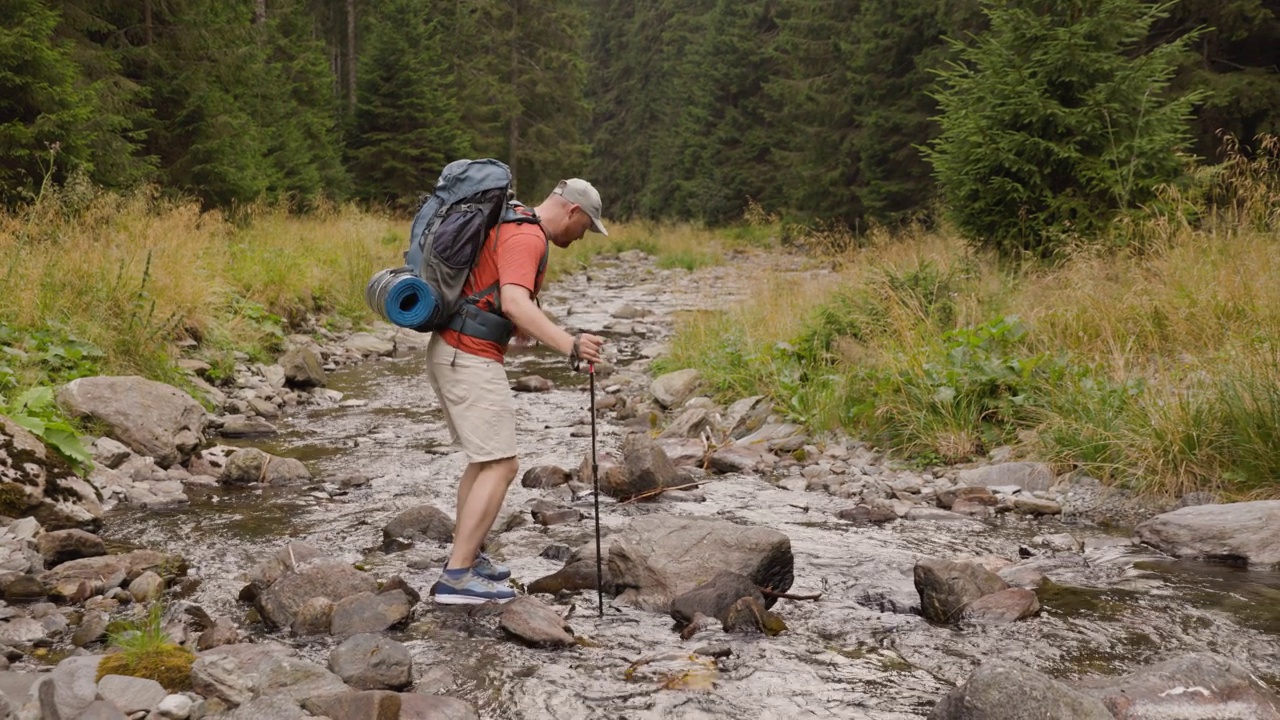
1137, 500, 1280, 568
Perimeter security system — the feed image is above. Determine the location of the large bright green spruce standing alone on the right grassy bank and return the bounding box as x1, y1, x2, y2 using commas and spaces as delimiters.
929, 0, 1196, 256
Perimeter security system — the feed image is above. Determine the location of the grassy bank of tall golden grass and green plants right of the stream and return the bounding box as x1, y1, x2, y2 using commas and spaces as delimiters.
659, 224, 1280, 500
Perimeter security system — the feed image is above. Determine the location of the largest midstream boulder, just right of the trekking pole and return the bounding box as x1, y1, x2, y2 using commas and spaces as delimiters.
608, 515, 794, 612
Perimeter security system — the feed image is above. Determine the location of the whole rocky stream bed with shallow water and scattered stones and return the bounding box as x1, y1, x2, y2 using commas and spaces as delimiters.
0, 252, 1280, 720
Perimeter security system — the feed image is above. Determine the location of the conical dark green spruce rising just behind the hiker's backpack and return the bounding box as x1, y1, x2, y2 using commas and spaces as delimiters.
349, 0, 470, 208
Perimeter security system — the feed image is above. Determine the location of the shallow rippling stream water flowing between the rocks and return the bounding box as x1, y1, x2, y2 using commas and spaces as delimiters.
104, 249, 1280, 720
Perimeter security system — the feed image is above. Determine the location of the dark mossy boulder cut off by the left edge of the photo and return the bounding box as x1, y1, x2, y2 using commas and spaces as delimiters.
0, 416, 102, 530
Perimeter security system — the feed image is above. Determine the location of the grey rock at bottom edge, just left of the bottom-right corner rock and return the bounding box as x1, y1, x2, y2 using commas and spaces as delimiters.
929, 660, 1115, 720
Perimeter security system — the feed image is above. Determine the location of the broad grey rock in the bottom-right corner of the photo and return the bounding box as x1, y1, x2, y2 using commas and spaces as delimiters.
1079, 652, 1280, 720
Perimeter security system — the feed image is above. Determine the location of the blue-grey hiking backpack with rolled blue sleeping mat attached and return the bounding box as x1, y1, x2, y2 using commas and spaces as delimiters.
365, 159, 547, 345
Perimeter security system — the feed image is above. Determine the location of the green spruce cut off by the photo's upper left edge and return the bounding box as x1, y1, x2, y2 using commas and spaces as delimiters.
0, 0, 93, 205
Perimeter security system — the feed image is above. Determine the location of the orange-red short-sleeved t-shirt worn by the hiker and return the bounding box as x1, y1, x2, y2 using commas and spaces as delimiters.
438, 223, 549, 363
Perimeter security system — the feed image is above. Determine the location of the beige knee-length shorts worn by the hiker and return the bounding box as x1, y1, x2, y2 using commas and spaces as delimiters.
426, 334, 516, 462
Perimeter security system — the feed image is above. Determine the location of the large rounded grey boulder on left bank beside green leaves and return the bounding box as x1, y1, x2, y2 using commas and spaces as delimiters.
58, 375, 209, 468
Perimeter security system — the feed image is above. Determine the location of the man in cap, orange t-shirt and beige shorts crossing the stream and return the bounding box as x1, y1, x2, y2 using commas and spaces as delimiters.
428, 178, 608, 605
